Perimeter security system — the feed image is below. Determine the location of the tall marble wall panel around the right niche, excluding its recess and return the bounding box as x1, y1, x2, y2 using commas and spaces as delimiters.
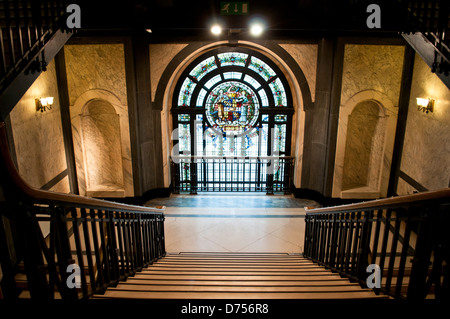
332, 44, 405, 198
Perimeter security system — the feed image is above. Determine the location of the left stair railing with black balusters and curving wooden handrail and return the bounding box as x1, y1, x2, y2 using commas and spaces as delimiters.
0, 123, 165, 299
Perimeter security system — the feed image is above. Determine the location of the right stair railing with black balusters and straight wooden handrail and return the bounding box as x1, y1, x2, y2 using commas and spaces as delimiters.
303, 189, 450, 300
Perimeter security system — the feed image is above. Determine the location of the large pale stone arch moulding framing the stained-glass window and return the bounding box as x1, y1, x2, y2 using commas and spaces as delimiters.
154, 41, 313, 187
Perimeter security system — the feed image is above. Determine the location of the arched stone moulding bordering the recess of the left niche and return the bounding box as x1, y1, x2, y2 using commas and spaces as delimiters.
70, 89, 134, 197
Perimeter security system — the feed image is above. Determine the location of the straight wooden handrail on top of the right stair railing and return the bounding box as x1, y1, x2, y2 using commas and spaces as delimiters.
305, 188, 450, 214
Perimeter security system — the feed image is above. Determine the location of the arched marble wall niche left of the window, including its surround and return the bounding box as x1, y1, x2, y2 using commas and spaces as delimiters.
70, 89, 134, 197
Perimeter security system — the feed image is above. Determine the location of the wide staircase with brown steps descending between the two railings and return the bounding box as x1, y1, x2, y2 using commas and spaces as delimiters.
93, 252, 385, 299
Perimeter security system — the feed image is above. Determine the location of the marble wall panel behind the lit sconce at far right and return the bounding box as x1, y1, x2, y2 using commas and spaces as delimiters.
397, 54, 450, 195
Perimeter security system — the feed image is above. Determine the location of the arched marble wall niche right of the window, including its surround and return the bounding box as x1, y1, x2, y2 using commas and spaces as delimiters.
333, 90, 398, 199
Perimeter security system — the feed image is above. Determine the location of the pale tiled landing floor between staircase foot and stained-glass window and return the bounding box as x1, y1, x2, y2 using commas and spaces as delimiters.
146, 194, 318, 253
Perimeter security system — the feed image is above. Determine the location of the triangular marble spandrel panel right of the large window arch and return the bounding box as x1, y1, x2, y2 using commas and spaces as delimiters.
280, 44, 318, 101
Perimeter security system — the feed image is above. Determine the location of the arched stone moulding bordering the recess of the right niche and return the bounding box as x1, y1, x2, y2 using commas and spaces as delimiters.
332, 90, 398, 199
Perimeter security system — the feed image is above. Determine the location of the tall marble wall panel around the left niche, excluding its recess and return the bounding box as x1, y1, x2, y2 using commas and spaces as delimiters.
64, 44, 134, 197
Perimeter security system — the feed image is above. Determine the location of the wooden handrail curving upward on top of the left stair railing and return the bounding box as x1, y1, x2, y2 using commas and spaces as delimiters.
0, 122, 164, 214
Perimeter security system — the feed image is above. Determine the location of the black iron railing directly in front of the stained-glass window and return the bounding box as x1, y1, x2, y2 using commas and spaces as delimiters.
171, 156, 294, 194
